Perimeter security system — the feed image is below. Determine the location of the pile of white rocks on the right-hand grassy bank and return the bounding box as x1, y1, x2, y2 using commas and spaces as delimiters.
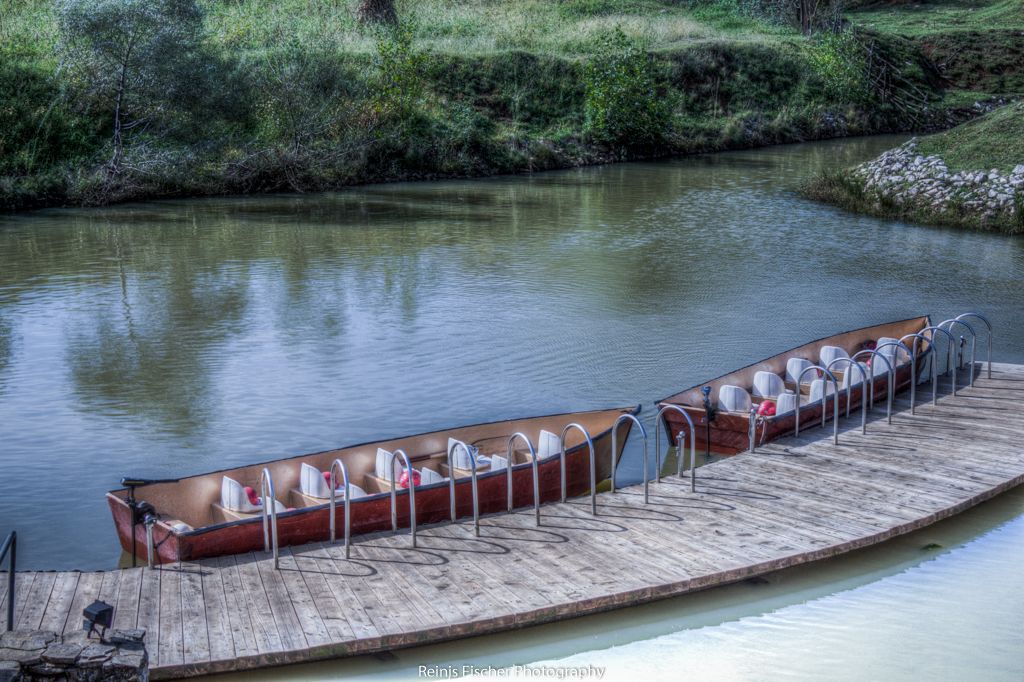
853, 138, 1024, 222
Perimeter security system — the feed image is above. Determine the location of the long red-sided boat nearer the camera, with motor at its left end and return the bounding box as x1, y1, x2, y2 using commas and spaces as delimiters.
106, 406, 640, 563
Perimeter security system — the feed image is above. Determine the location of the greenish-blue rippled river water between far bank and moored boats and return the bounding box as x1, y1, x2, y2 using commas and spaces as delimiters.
0, 138, 1024, 568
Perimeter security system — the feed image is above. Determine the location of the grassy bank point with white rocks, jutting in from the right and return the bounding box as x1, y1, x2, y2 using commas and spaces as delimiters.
806, 103, 1024, 235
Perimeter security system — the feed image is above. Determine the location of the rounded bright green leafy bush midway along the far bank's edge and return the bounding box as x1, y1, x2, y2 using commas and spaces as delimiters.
584, 29, 672, 146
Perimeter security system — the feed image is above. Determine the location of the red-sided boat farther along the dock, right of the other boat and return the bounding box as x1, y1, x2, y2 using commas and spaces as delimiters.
657, 315, 931, 455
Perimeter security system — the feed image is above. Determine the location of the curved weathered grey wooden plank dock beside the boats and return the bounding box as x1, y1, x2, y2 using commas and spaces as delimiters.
0, 365, 1024, 678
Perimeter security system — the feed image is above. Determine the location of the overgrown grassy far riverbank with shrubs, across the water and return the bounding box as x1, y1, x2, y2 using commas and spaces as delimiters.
0, 0, 1016, 208
